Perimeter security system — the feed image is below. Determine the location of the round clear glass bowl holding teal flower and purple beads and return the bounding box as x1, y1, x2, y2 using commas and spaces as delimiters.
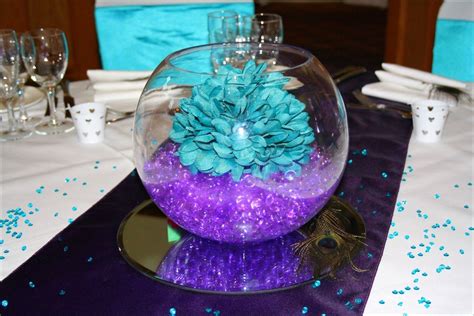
133, 43, 348, 243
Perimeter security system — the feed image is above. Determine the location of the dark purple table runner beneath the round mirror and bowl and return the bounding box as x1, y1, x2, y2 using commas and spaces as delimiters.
0, 75, 411, 315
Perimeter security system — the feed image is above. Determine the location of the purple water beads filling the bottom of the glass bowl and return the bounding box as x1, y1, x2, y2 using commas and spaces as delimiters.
141, 142, 340, 243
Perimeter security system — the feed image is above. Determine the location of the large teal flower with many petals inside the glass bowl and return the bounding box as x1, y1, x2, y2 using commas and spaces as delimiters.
170, 61, 314, 181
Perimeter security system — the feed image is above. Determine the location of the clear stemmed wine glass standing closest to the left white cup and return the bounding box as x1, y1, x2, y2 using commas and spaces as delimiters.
21, 28, 74, 135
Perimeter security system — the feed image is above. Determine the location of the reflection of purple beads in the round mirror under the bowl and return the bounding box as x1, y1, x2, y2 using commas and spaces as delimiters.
156, 232, 312, 292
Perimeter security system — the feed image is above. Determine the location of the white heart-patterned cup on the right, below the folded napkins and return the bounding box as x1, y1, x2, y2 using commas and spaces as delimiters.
411, 99, 449, 143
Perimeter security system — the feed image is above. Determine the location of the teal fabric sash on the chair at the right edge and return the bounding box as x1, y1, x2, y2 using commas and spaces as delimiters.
433, 19, 474, 82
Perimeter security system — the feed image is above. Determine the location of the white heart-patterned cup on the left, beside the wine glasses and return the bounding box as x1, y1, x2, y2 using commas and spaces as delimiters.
69, 102, 106, 144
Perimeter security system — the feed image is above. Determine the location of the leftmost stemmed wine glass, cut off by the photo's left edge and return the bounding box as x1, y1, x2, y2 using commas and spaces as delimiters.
0, 30, 31, 141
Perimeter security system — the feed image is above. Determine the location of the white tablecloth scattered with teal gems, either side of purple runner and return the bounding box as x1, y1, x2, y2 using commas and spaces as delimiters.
0, 81, 474, 315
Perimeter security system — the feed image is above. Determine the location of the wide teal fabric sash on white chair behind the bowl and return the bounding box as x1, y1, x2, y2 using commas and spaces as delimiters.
95, 2, 254, 70
